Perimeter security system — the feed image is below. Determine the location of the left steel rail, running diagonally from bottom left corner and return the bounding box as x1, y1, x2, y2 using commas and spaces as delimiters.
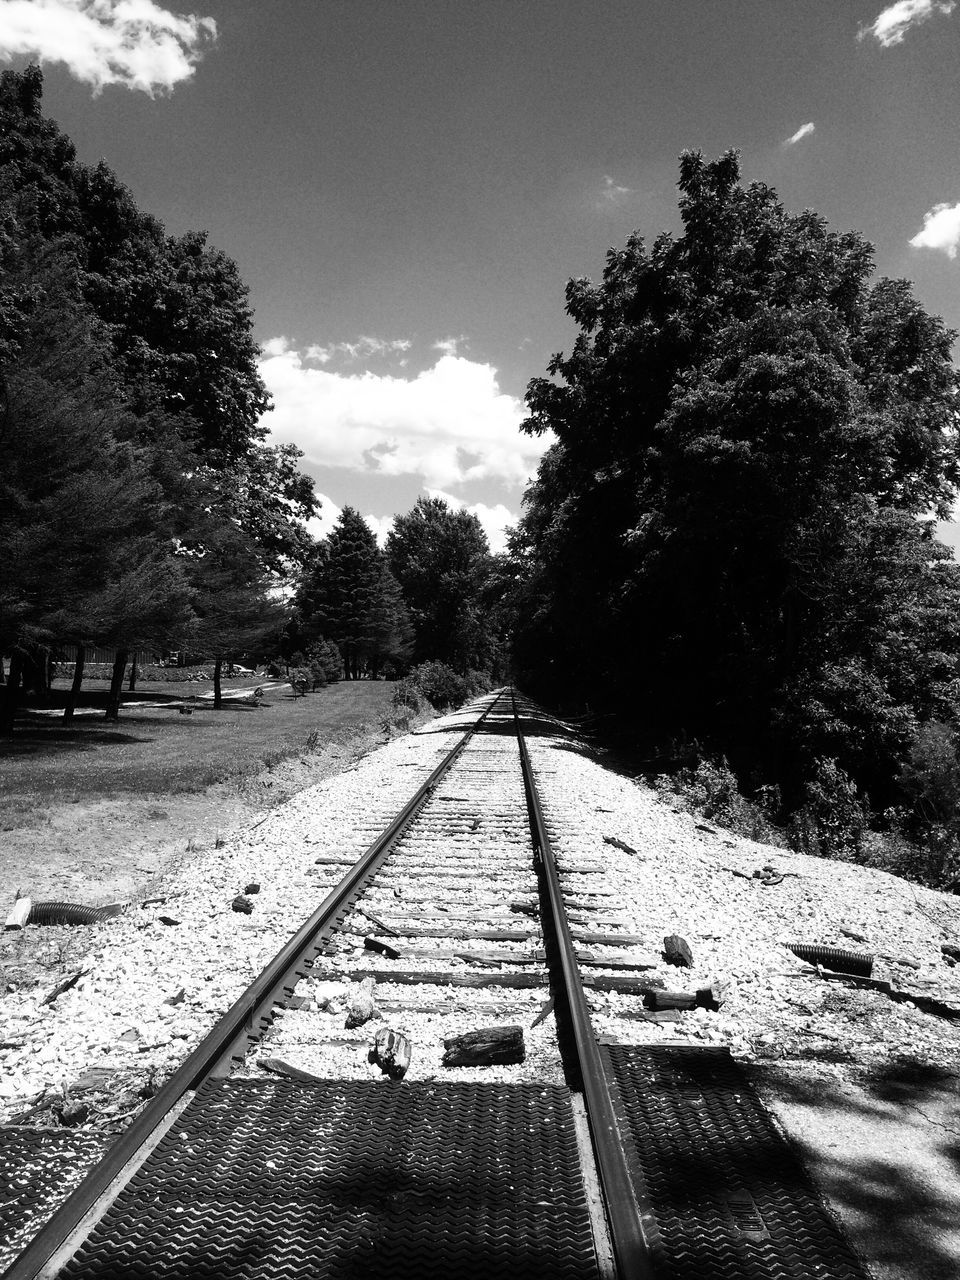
0, 692, 504, 1280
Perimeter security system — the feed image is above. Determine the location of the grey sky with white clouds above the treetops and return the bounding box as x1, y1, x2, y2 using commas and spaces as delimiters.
0, 0, 960, 549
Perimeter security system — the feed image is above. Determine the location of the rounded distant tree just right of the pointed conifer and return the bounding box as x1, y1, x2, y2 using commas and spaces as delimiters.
385, 498, 494, 672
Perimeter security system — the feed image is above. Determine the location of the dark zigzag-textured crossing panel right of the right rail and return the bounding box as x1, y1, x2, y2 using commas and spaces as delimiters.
600, 1046, 869, 1280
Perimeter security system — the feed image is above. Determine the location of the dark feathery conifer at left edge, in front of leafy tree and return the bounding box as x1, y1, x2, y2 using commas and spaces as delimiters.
0, 231, 189, 732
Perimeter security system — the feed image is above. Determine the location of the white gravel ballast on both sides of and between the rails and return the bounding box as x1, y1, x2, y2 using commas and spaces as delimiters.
0, 691, 960, 1123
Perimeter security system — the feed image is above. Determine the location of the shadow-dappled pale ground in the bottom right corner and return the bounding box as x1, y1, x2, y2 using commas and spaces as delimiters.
753, 1059, 960, 1280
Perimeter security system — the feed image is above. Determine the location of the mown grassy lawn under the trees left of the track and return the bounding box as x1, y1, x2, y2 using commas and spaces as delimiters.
0, 680, 393, 828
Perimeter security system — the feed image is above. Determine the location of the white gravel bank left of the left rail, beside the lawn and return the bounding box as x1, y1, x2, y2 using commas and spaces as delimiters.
0, 717, 465, 1124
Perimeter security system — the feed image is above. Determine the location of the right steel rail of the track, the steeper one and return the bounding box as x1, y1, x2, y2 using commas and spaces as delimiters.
511, 691, 654, 1280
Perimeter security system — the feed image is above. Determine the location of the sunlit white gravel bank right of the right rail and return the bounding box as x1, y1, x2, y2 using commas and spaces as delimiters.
530, 739, 960, 1068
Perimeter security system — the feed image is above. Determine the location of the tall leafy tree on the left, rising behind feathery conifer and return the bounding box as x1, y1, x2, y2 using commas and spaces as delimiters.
0, 67, 317, 572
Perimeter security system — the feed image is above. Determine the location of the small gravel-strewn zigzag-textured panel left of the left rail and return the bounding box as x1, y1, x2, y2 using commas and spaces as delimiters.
0, 1126, 110, 1271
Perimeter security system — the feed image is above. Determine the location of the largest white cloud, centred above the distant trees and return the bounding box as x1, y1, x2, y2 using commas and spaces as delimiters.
260, 338, 550, 489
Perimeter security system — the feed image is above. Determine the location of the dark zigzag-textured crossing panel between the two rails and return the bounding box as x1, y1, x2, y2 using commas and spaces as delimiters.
64, 1079, 596, 1280
